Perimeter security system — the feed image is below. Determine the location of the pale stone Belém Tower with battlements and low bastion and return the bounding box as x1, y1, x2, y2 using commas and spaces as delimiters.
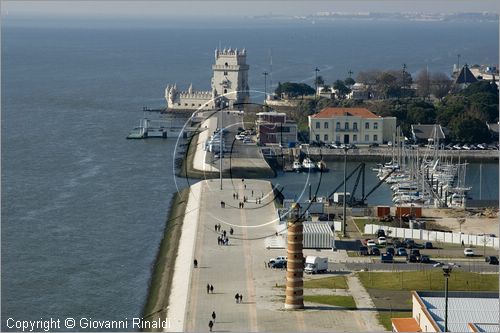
165, 48, 250, 111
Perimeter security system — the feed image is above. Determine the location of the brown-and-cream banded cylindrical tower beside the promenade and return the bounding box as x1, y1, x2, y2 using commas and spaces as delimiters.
285, 218, 304, 310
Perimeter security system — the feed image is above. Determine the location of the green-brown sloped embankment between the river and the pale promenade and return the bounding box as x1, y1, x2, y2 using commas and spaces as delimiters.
143, 188, 189, 331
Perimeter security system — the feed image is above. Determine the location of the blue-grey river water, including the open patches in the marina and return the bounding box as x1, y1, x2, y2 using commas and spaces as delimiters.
1, 16, 498, 330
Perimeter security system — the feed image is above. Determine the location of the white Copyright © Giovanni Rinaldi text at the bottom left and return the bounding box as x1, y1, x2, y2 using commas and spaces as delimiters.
6, 317, 170, 332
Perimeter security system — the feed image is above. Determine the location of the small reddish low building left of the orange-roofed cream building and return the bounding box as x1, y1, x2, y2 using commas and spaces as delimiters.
255, 111, 297, 145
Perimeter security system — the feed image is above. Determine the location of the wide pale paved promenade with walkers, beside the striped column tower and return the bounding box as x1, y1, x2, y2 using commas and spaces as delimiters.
168, 179, 380, 332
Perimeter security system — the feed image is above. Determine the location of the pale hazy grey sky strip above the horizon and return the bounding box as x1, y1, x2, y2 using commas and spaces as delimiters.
1, 0, 500, 17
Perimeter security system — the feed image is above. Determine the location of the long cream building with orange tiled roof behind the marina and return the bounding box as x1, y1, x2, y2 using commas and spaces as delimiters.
309, 108, 396, 144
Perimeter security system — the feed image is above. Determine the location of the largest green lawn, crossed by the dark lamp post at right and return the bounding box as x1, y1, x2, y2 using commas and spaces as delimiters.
358, 269, 498, 291
